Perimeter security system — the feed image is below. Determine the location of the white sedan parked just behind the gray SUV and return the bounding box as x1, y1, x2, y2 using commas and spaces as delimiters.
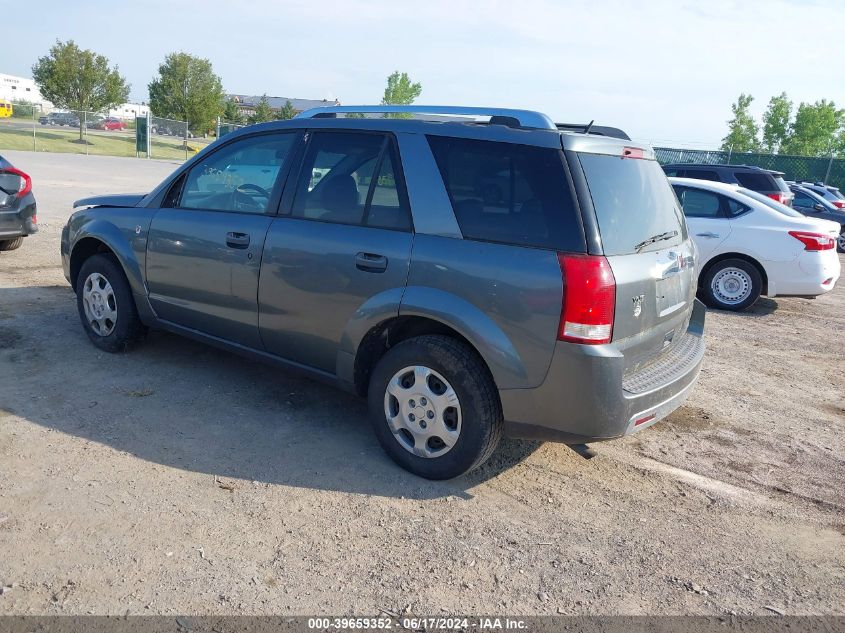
669, 178, 840, 310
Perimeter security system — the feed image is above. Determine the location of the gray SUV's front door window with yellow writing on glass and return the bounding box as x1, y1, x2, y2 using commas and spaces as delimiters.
179, 133, 296, 213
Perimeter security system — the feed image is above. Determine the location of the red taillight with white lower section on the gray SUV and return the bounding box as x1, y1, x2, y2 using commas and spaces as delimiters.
557, 254, 616, 345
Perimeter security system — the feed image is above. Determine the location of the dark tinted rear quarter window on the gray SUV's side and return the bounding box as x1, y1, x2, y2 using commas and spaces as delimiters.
428, 136, 586, 253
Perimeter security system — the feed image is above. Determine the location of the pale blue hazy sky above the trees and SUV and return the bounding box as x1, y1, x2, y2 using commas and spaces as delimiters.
0, 0, 845, 147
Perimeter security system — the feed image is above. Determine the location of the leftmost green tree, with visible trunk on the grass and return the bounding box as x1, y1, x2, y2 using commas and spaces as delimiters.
32, 40, 129, 142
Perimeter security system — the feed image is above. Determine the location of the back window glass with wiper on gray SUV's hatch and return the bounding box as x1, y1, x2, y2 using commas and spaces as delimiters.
578, 154, 686, 255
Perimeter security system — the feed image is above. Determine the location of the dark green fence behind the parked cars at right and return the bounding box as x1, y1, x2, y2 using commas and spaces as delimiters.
654, 147, 845, 189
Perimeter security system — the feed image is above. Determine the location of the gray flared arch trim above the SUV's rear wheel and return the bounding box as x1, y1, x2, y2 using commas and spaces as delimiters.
399, 286, 529, 389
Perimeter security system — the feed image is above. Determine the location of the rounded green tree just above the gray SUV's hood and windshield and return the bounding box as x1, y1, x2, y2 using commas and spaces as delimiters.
149, 53, 223, 133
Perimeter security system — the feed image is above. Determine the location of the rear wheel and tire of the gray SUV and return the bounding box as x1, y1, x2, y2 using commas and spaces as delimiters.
368, 335, 504, 480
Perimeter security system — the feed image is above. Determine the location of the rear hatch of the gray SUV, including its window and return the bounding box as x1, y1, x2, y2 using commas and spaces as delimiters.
567, 142, 697, 378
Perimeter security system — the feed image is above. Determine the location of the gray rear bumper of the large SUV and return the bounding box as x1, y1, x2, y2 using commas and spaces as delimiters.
499, 300, 706, 444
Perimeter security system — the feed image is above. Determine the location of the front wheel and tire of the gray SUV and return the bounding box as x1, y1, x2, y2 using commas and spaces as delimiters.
76, 254, 146, 353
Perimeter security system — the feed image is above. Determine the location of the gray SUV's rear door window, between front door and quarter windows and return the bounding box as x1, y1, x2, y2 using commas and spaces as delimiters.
293, 132, 411, 231
